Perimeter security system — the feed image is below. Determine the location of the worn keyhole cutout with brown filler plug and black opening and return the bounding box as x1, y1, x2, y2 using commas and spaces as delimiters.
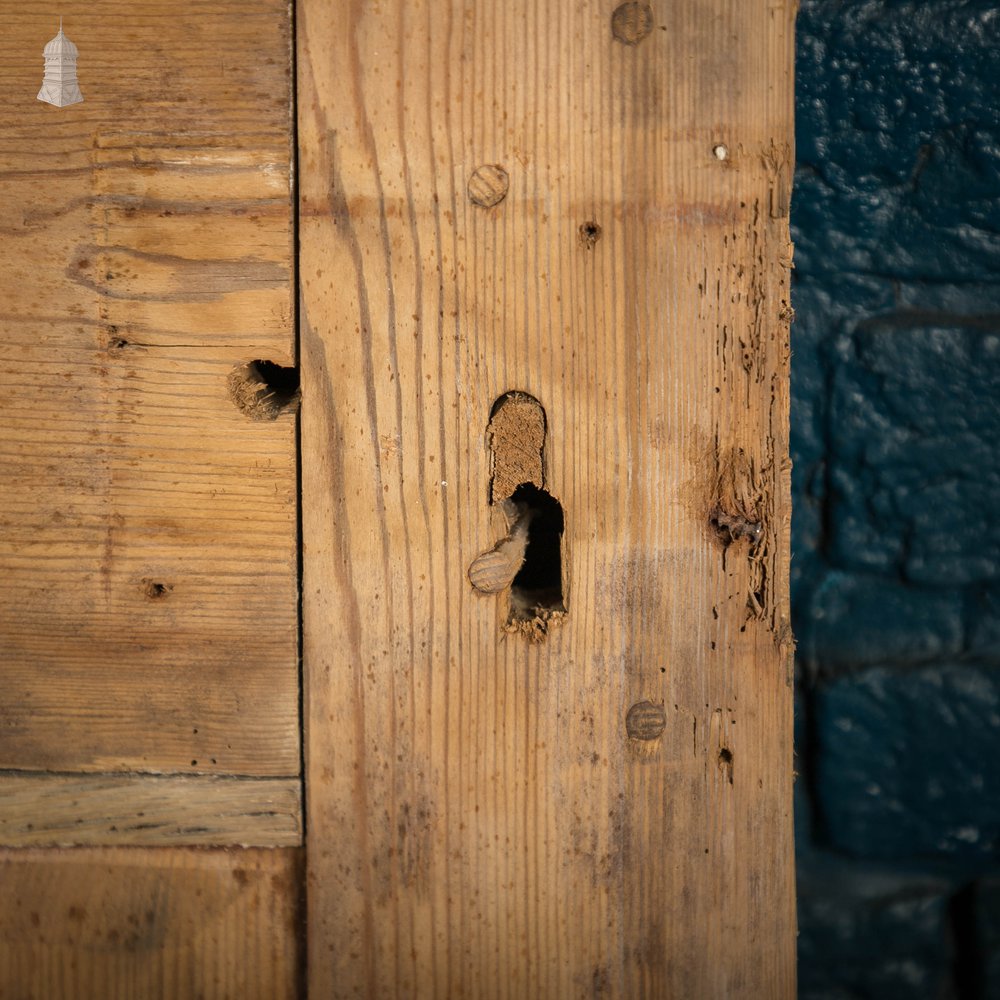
469, 392, 566, 641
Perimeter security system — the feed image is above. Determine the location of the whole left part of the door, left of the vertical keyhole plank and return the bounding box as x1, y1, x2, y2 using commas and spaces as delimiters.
0, 0, 302, 1000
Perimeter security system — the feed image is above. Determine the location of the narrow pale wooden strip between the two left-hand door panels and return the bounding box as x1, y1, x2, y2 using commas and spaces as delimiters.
0, 772, 302, 847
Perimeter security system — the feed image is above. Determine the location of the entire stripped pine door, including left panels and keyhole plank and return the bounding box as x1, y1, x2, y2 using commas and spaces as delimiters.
0, 0, 794, 1000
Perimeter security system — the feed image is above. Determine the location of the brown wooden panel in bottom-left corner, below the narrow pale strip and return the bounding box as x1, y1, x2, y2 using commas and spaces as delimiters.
0, 848, 302, 1000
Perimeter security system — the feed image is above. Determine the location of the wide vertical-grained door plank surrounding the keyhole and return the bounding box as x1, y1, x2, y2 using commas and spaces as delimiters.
297, 0, 795, 1000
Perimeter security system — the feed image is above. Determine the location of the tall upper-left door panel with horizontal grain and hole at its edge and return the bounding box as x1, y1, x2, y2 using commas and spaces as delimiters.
0, 0, 299, 776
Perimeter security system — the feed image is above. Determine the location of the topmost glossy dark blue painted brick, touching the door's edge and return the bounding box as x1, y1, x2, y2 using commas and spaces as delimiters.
794, 0, 1000, 282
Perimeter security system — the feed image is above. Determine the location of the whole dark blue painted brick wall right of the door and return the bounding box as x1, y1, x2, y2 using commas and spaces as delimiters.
792, 0, 1000, 1000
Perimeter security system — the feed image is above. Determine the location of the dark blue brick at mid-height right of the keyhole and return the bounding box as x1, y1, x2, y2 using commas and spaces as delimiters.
828, 317, 1000, 586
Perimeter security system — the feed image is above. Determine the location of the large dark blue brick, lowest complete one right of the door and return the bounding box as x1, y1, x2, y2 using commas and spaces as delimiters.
815, 664, 1000, 863
